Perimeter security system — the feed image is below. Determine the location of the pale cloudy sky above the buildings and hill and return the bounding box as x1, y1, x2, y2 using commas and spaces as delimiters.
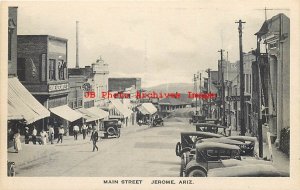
14, 0, 291, 87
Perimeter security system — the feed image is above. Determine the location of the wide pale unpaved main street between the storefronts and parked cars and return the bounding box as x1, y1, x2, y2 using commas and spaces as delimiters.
17, 118, 195, 177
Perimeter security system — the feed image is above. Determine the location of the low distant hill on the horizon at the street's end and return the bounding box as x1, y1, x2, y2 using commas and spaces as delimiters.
143, 83, 194, 93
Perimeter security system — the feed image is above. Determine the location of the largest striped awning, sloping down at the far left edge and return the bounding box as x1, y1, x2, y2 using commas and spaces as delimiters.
7, 77, 50, 124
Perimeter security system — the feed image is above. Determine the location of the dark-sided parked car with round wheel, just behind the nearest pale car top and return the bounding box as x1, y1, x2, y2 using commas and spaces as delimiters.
184, 142, 241, 177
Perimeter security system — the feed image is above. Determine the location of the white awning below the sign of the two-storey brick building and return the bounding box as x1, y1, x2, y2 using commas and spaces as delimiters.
50, 105, 84, 122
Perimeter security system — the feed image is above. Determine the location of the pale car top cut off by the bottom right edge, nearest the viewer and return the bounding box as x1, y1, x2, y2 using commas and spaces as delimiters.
207, 163, 286, 177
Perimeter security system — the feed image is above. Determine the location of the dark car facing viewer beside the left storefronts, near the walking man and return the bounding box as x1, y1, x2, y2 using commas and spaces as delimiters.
101, 119, 121, 138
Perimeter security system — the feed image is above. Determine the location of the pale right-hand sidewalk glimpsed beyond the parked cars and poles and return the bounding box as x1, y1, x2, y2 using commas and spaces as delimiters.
231, 131, 290, 174
